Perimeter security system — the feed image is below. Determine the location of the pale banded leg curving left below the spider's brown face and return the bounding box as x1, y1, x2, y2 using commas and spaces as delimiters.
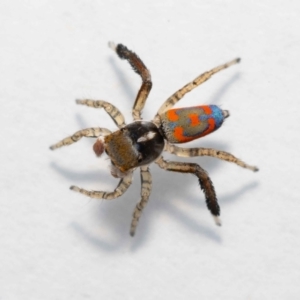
70, 172, 133, 200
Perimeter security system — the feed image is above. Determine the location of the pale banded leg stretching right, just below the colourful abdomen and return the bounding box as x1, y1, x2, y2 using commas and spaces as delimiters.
165, 144, 259, 172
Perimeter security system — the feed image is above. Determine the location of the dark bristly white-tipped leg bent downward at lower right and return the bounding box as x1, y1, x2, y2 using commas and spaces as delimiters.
155, 157, 221, 226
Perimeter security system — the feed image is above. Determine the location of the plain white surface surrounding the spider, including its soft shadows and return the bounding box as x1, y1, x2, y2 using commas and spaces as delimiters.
0, 0, 300, 300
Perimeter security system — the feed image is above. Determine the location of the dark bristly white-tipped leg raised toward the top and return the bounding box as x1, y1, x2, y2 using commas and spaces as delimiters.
109, 42, 152, 121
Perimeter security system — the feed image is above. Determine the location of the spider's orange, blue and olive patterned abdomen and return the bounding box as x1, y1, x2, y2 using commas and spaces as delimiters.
160, 105, 229, 144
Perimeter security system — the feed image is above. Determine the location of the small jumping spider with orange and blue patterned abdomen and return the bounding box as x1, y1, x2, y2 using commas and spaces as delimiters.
50, 42, 258, 236
